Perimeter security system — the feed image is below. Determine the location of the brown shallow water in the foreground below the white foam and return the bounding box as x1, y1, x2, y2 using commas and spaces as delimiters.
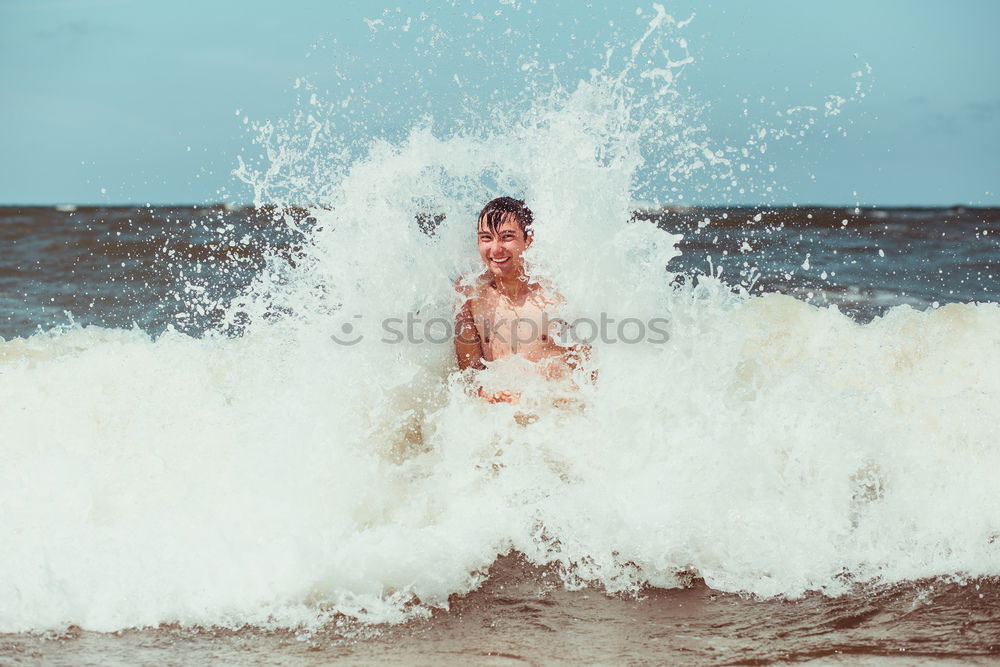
0, 556, 1000, 666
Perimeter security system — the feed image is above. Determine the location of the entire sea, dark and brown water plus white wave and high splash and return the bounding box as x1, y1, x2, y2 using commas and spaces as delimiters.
0, 6, 1000, 665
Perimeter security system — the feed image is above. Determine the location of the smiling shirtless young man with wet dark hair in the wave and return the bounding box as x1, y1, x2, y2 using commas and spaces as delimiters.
455, 197, 581, 403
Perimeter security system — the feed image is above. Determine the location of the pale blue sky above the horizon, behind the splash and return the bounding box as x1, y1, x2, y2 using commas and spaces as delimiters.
0, 0, 1000, 205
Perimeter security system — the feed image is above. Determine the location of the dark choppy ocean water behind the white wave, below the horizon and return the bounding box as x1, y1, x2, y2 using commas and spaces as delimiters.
0, 206, 1000, 339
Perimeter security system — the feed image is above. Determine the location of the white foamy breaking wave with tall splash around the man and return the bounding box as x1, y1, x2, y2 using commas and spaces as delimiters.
0, 1, 1000, 632
